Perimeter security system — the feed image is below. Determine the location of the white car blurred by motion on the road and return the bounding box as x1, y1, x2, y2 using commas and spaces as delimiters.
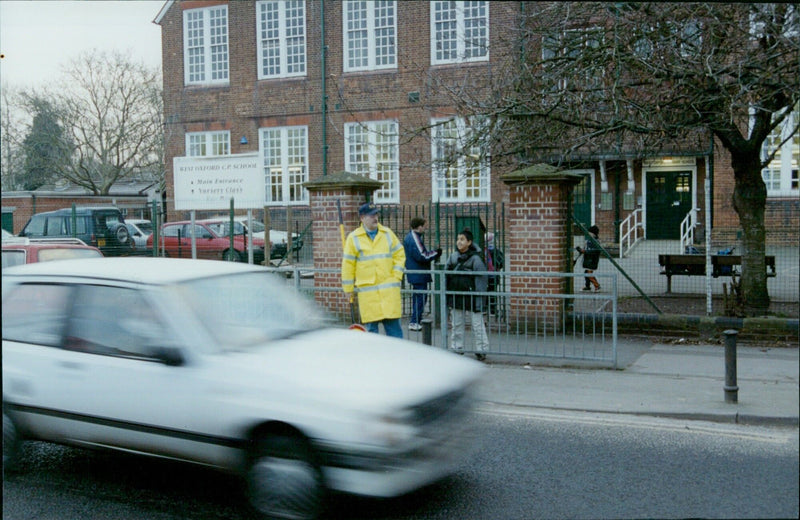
2, 257, 484, 518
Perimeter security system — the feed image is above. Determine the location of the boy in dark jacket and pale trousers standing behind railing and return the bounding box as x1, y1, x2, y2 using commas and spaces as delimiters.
445, 229, 489, 361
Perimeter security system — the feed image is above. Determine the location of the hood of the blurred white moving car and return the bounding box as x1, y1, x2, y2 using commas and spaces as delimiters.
208, 329, 485, 410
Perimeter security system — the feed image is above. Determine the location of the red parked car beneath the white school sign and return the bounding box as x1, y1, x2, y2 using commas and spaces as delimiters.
147, 219, 264, 264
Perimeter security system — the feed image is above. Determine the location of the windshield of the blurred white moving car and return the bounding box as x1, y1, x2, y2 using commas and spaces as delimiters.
174, 271, 327, 350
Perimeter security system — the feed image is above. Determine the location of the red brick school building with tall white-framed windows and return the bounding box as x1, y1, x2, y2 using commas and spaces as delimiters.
155, 0, 800, 245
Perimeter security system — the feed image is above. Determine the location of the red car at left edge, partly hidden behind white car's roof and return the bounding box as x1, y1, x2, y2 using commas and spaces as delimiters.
2, 235, 103, 269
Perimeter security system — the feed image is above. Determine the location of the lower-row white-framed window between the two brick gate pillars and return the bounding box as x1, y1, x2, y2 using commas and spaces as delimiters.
431, 118, 491, 202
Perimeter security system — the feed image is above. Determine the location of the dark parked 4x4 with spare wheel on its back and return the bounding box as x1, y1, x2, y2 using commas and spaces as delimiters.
19, 206, 134, 256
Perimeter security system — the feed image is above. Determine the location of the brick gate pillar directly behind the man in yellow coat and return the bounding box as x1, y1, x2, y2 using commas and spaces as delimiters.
303, 172, 383, 319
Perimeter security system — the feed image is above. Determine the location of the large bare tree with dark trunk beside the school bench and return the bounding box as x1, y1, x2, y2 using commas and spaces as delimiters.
446, 2, 800, 314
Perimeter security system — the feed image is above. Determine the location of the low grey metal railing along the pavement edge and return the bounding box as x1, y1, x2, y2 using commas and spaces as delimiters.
274, 266, 617, 368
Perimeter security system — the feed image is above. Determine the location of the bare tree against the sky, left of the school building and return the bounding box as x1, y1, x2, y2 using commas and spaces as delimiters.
55, 51, 164, 195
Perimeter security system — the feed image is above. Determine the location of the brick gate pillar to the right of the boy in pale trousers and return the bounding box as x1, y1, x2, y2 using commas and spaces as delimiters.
502, 164, 581, 324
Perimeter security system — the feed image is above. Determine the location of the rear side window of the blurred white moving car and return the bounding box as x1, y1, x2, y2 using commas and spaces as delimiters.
3, 283, 73, 347
